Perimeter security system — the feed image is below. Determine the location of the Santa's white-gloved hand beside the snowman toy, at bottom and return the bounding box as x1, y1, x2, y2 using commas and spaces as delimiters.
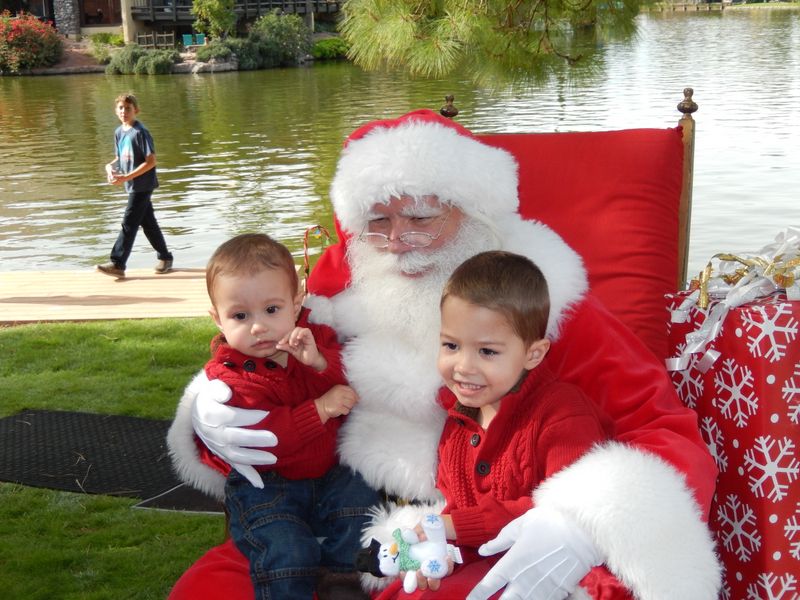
467, 508, 602, 600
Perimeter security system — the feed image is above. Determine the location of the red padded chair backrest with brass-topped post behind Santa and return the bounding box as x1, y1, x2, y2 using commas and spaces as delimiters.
468, 88, 697, 358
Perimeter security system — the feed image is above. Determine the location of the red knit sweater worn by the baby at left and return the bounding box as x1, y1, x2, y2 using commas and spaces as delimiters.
198, 309, 347, 479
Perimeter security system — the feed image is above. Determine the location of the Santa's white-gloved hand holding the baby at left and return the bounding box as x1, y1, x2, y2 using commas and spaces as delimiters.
192, 373, 278, 488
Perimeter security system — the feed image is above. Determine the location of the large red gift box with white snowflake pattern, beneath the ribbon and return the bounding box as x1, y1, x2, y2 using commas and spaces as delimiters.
667, 292, 800, 600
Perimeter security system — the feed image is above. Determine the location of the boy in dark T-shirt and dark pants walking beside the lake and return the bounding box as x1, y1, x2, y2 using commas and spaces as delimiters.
97, 94, 172, 277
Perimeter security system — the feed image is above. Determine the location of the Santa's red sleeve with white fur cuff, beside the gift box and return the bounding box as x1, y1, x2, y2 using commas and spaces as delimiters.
533, 296, 720, 599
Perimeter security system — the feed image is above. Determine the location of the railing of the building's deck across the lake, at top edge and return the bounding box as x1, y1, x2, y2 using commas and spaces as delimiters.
131, 0, 342, 23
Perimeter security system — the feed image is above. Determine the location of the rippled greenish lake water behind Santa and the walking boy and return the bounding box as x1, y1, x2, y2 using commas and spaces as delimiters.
0, 8, 800, 282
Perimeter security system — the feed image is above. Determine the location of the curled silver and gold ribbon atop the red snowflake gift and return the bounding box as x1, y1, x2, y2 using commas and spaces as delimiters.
666, 227, 800, 373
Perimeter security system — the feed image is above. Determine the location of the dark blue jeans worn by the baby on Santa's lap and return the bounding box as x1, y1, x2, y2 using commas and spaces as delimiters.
225, 466, 379, 600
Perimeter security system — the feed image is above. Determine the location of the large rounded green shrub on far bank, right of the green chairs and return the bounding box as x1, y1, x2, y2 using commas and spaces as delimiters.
249, 9, 311, 67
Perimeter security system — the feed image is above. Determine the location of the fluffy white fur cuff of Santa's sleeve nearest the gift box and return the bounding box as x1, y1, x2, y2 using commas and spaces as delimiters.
533, 443, 720, 600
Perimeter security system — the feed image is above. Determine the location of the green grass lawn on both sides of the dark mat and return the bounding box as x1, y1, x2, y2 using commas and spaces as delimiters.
0, 318, 224, 600
